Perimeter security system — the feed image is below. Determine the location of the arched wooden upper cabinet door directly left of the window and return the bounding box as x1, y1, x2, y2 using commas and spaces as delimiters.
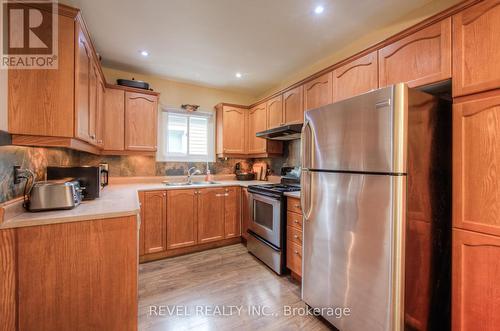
125, 92, 158, 151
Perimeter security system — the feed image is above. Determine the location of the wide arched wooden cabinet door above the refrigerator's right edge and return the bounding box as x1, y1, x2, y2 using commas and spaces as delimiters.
379, 18, 451, 87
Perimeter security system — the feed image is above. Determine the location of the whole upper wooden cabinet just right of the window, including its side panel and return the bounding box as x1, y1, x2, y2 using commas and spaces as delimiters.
215, 104, 248, 157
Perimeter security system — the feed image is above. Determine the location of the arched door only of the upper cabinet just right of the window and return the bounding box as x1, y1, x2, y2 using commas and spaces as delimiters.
222, 106, 247, 154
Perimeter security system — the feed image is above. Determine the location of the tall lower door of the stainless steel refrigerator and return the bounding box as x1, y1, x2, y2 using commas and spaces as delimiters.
302, 171, 406, 331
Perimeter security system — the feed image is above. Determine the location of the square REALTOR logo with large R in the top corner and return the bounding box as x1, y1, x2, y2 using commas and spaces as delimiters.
0, 0, 58, 69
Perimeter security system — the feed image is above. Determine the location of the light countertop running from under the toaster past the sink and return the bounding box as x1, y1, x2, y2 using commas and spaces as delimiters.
0, 180, 269, 229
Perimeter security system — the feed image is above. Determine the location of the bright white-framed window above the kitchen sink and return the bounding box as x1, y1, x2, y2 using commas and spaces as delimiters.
157, 109, 215, 162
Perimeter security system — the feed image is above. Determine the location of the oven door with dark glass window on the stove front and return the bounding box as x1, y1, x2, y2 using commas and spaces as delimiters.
248, 193, 282, 249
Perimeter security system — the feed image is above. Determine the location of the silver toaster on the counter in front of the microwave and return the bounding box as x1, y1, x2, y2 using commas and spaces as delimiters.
27, 179, 82, 211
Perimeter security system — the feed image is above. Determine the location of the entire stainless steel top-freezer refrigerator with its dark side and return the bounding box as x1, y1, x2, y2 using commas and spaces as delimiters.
301, 84, 451, 331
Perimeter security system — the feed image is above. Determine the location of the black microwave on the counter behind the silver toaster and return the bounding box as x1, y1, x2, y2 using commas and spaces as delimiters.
47, 164, 108, 200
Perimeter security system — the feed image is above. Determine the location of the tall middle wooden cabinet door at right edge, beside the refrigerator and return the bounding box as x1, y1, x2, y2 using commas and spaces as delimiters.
453, 91, 500, 236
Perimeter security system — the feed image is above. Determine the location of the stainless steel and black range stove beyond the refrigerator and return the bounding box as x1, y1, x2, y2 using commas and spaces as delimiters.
247, 167, 300, 275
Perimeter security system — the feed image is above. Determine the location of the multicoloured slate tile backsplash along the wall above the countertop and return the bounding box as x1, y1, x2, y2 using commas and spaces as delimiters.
0, 140, 300, 203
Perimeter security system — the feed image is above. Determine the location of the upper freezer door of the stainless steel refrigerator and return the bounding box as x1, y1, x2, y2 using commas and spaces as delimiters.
302, 84, 408, 173
